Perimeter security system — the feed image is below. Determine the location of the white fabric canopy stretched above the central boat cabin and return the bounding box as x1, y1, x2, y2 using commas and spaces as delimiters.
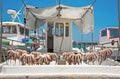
25, 5, 94, 34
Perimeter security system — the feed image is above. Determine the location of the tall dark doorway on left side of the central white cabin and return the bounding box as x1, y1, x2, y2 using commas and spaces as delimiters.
47, 22, 54, 52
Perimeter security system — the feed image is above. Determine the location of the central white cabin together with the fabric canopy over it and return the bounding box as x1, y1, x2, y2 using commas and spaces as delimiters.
25, 4, 94, 52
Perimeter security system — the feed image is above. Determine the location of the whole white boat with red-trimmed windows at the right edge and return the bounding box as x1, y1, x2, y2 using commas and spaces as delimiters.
99, 27, 120, 57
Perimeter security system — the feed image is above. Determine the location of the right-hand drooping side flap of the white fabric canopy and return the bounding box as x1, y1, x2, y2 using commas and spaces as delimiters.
74, 9, 94, 34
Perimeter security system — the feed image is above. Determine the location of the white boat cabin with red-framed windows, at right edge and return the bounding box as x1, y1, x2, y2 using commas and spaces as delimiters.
100, 27, 120, 47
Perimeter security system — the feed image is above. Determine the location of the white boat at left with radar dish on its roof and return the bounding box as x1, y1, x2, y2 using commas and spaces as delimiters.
2, 9, 29, 47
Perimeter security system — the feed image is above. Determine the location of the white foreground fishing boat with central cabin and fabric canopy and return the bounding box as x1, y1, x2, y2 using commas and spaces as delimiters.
0, 0, 120, 79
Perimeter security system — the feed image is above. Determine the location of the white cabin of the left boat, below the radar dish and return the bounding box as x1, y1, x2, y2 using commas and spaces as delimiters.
2, 22, 29, 42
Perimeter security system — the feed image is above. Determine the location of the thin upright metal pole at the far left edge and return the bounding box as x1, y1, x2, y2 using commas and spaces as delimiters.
0, 0, 2, 62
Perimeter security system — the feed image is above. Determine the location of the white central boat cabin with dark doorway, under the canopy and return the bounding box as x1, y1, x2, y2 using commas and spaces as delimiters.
46, 19, 72, 52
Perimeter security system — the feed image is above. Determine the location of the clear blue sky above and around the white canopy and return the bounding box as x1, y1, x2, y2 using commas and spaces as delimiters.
2, 0, 118, 42
